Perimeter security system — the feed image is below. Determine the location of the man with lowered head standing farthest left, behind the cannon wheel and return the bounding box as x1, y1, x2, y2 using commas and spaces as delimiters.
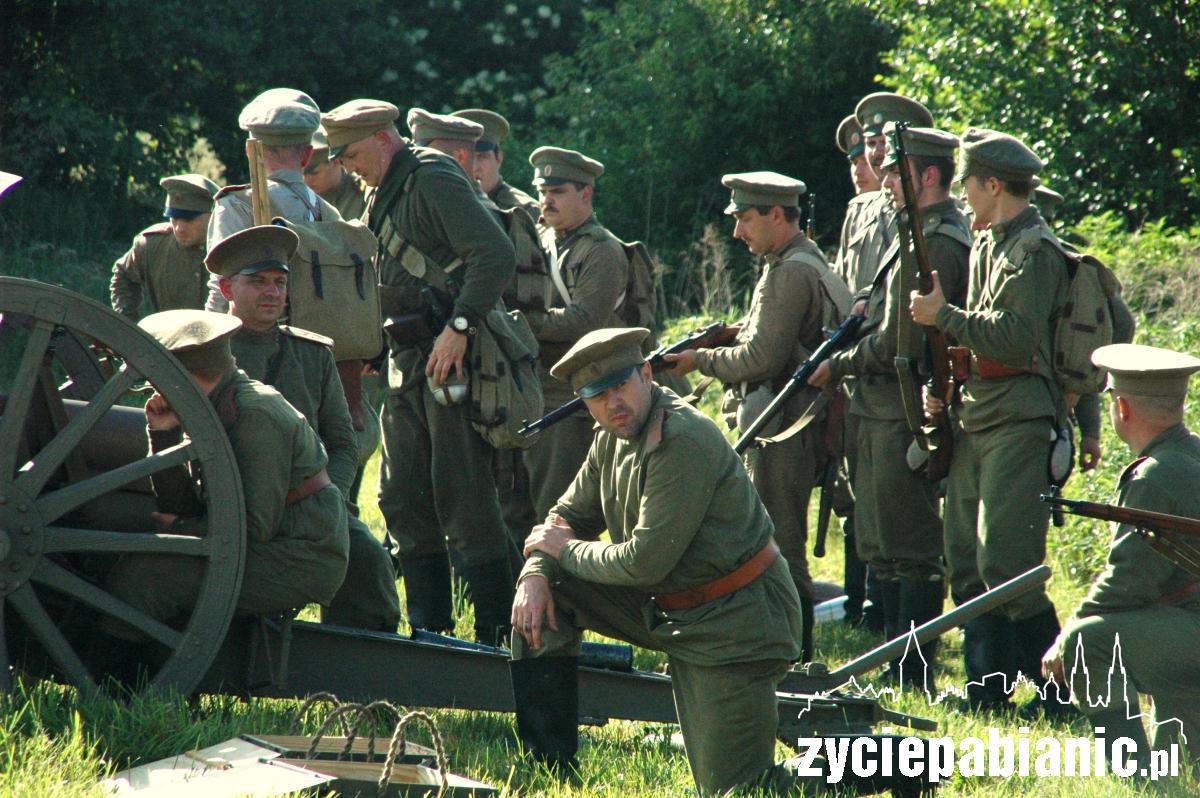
108, 174, 217, 322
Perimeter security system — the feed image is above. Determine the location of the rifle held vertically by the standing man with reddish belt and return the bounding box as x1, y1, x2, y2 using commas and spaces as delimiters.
892, 122, 954, 480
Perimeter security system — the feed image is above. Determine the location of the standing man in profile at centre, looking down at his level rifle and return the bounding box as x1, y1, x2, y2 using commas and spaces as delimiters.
666, 172, 850, 661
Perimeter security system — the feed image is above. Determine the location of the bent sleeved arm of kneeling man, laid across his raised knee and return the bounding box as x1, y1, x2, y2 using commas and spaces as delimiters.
559, 434, 716, 587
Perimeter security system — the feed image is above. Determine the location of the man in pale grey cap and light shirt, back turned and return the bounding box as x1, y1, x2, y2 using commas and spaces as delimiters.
206, 89, 342, 313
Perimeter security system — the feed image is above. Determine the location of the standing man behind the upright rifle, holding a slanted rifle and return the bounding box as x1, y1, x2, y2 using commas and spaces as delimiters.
809, 127, 971, 688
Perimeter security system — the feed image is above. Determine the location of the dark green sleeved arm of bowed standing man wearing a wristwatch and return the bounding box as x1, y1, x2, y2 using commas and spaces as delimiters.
414, 164, 516, 319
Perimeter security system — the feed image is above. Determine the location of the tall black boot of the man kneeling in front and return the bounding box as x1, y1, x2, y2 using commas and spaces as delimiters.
509, 656, 580, 779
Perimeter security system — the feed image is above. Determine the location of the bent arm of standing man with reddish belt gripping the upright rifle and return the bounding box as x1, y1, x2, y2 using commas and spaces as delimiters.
937, 244, 1066, 366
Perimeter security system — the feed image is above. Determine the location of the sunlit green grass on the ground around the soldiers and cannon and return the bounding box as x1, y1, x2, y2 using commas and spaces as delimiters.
0, 208, 1200, 798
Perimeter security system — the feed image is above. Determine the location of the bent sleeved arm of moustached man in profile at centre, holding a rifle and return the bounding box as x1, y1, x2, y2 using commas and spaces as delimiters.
696, 264, 821, 383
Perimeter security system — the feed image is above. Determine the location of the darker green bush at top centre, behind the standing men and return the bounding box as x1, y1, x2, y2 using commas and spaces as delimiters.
538, 0, 893, 266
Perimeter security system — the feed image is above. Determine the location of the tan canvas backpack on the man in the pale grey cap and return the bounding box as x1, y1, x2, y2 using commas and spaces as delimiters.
274, 217, 383, 360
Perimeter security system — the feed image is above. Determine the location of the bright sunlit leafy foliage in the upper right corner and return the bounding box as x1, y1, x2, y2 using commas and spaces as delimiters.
864, 0, 1200, 226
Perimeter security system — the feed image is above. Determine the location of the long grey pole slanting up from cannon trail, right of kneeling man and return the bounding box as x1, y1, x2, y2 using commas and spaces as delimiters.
779, 565, 1052, 692
